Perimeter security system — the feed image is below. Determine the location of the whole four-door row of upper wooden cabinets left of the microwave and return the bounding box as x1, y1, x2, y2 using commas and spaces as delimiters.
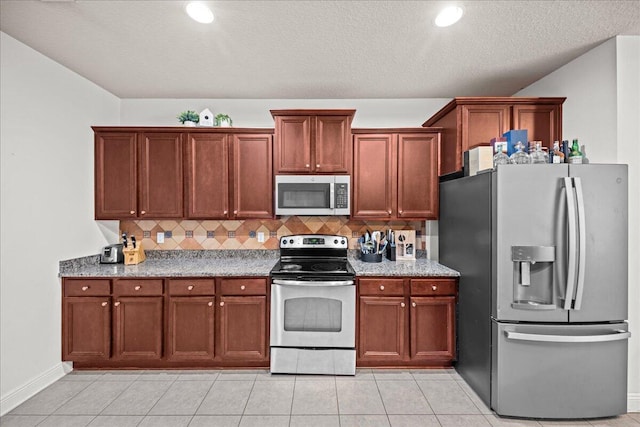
93, 127, 273, 219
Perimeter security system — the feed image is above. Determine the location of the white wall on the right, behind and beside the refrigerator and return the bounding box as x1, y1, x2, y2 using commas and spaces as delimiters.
515, 36, 640, 411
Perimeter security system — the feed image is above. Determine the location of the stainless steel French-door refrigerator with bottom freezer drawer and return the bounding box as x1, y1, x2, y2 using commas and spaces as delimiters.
439, 164, 630, 418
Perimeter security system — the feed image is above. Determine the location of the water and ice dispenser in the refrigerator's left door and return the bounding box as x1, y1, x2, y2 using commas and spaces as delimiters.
511, 246, 556, 310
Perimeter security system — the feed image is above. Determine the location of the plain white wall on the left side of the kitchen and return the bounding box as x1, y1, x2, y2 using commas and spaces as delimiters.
0, 33, 120, 414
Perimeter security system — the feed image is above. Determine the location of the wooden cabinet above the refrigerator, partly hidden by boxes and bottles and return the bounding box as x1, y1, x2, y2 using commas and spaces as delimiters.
423, 97, 566, 175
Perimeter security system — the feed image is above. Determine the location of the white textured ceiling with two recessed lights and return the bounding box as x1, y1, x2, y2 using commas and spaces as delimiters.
0, 0, 640, 99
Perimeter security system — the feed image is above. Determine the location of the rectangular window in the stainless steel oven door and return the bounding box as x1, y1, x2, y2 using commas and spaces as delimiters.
284, 297, 342, 332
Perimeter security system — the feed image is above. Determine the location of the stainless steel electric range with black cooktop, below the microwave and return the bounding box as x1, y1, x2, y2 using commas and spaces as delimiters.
270, 235, 356, 375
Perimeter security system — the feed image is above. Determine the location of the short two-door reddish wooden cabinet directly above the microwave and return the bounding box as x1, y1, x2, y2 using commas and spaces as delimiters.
271, 110, 355, 174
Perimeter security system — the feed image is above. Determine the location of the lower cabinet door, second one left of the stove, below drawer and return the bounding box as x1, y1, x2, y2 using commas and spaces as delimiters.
167, 296, 215, 360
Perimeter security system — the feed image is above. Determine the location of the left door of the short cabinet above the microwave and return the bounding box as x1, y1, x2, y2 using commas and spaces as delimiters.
274, 116, 311, 173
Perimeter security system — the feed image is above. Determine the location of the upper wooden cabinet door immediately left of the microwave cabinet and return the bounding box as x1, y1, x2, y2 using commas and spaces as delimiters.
231, 134, 273, 218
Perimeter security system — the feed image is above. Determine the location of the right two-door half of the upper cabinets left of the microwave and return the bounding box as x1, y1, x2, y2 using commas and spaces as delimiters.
186, 133, 273, 219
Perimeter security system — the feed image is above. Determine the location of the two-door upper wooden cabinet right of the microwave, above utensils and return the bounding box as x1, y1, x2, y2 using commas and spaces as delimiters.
352, 128, 440, 220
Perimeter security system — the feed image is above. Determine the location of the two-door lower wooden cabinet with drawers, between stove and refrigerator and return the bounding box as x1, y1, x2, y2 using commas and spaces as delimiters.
357, 278, 456, 367
